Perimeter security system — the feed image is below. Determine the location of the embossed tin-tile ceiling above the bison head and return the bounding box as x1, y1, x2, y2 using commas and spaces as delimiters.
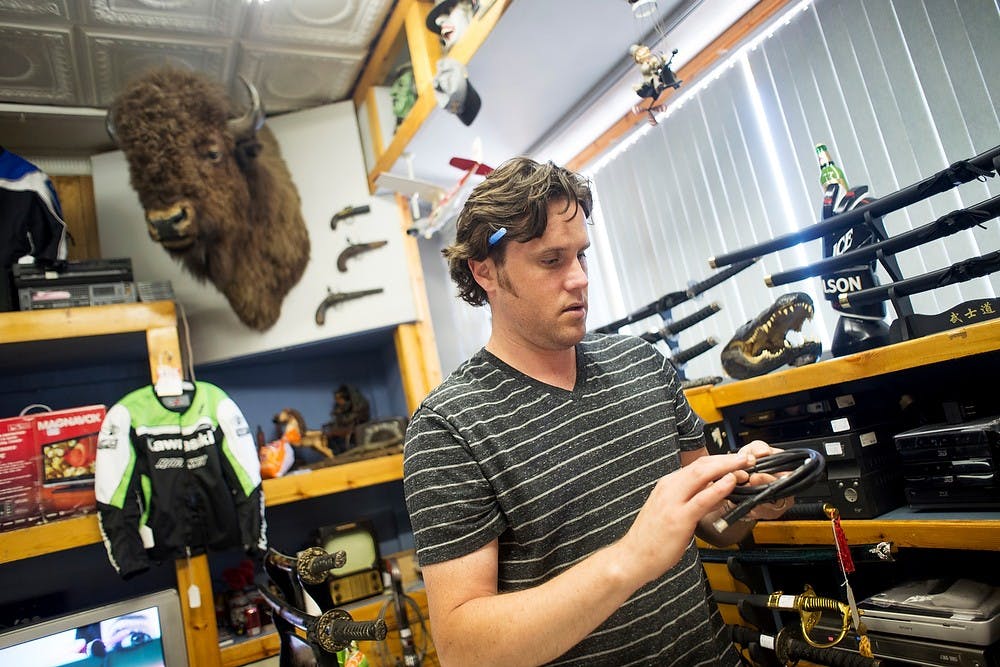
0, 0, 393, 157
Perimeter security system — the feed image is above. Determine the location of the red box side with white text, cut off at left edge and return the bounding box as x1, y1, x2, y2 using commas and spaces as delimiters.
0, 417, 41, 530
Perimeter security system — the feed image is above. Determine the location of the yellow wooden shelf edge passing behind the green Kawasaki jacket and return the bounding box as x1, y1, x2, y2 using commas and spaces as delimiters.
0, 454, 403, 564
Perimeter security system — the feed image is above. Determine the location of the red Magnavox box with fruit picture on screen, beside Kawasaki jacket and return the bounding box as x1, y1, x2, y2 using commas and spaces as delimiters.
30, 405, 106, 520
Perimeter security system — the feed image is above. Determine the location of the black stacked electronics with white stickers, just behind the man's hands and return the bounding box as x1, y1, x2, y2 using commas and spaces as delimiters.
737, 393, 905, 519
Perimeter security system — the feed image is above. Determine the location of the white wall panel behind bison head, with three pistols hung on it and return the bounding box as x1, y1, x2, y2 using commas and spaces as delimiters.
92, 101, 416, 363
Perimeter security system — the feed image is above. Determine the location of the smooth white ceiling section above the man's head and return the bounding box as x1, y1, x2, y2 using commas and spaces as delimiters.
402, 0, 757, 183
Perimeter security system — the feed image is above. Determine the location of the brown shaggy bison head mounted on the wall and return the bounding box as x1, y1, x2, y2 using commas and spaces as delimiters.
107, 69, 309, 331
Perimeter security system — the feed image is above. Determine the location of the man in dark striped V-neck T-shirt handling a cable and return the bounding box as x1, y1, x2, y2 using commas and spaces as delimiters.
404, 158, 781, 667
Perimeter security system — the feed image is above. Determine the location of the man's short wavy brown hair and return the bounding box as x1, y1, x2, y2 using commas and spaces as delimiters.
442, 157, 593, 306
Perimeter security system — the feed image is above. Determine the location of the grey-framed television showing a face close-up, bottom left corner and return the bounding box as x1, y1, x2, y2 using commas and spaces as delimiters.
0, 590, 188, 667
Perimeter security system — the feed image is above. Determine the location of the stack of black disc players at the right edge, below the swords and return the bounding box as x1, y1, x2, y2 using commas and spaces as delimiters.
895, 416, 1000, 510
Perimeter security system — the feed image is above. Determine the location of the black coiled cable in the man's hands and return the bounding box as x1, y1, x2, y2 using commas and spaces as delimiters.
713, 449, 826, 533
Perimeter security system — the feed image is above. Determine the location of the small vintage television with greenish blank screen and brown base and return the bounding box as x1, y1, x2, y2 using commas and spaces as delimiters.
316, 519, 385, 605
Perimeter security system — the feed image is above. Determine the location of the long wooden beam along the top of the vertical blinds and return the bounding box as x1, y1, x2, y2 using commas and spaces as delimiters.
566, 0, 791, 171
